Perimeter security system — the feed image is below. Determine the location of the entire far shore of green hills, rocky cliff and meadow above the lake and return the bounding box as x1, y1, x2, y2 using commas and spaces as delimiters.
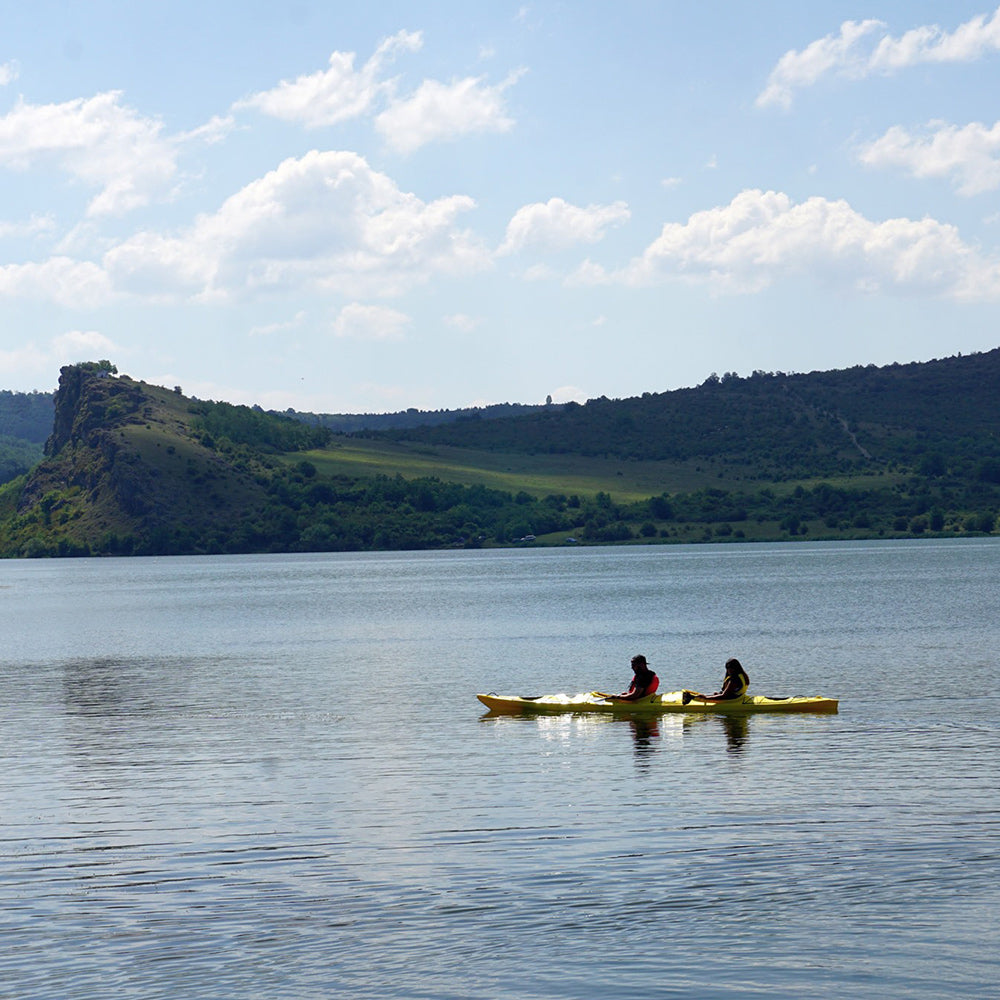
0, 350, 1000, 556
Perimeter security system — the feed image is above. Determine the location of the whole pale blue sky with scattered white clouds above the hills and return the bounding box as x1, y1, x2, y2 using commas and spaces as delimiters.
0, 0, 1000, 413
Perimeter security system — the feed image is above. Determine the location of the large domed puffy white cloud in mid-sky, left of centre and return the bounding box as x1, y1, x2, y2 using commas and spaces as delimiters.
104, 150, 489, 299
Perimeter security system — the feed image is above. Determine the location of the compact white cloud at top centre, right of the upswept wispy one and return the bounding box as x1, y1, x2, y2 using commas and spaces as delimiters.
375, 71, 522, 153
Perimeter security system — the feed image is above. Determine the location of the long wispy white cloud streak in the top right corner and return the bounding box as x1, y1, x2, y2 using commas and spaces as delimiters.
757, 7, 1000, 108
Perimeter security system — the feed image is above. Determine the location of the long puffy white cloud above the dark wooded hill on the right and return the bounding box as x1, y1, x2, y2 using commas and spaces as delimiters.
577, 190, 1000, 300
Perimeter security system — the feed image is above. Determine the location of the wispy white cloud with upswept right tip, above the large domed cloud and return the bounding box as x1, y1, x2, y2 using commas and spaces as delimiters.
233, 31, 423, 128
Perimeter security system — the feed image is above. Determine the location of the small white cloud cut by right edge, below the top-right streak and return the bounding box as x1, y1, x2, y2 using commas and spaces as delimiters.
859, 122, 1000, 195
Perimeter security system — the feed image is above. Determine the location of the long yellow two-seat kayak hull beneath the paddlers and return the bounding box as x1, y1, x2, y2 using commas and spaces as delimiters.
476, 691, 838, 715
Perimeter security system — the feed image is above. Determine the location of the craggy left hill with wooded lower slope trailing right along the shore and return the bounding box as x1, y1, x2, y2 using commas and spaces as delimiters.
0, 362, 592, 557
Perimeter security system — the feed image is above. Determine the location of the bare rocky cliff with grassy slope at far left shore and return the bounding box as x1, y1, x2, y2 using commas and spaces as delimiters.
0, 364, 265, 555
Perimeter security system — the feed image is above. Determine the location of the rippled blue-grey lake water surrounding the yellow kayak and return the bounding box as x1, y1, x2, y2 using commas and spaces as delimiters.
0, 540, 1000, 1000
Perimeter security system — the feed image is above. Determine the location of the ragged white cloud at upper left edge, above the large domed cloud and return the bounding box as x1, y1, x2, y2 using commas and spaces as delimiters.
0, 91, 226, 217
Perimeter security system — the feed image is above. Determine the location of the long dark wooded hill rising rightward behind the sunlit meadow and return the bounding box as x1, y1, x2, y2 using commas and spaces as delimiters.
368, 349, 1000, 481
